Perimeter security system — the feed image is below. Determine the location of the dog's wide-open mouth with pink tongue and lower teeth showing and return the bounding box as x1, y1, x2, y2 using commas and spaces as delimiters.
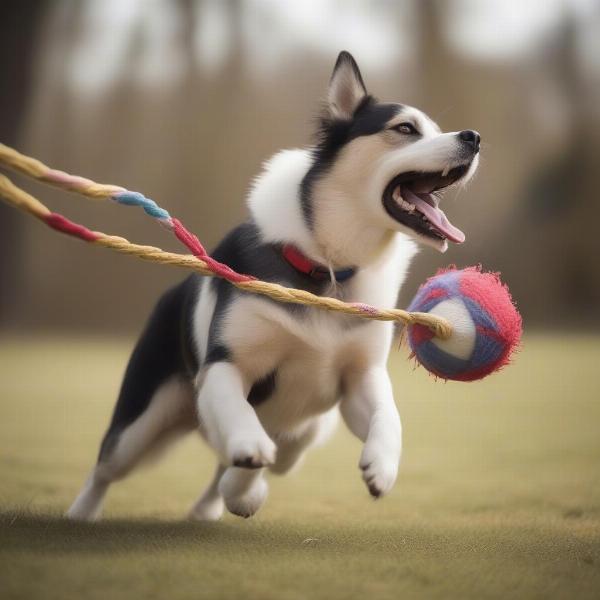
383, 166, 468, 244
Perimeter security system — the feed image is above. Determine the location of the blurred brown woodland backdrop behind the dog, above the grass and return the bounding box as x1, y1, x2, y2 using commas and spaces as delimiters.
0, 0, 600, 335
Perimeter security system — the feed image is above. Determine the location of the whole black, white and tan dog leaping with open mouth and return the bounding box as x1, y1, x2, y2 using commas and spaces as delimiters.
68, 52, 479, 520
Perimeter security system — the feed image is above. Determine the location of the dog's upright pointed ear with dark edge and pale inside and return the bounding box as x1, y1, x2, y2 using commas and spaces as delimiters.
327, 50, 367, 119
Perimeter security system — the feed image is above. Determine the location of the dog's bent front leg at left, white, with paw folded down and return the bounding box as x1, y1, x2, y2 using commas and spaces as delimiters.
197, 362, 276, 469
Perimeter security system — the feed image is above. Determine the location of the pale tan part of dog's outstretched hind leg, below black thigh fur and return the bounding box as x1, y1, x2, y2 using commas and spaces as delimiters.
67, 377, 196, 521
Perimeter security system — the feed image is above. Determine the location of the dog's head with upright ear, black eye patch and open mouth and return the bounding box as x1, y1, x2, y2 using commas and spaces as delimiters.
302, 52, 480, 252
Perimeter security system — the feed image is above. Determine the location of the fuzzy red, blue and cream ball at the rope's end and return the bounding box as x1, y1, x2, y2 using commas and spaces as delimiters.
407, 266, 522, 381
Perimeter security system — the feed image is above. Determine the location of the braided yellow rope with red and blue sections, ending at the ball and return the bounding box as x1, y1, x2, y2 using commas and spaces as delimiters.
0, 144, 452, 339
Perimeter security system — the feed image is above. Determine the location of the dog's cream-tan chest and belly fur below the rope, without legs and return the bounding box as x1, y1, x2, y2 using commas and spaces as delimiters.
224, 298, 381, 433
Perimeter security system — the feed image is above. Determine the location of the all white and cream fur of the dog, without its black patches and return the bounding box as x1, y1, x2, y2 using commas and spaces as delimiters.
68, 51, 477, 520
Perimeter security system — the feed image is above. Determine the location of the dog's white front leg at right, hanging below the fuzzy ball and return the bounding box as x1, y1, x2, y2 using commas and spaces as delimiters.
340, 367, 402, 498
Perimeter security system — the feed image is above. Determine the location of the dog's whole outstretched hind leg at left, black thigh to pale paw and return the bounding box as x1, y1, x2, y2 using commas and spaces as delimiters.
67, 277, 198, 520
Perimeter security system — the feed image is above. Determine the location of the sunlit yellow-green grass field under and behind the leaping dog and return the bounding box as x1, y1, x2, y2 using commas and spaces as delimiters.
0, 336, 600, 600
